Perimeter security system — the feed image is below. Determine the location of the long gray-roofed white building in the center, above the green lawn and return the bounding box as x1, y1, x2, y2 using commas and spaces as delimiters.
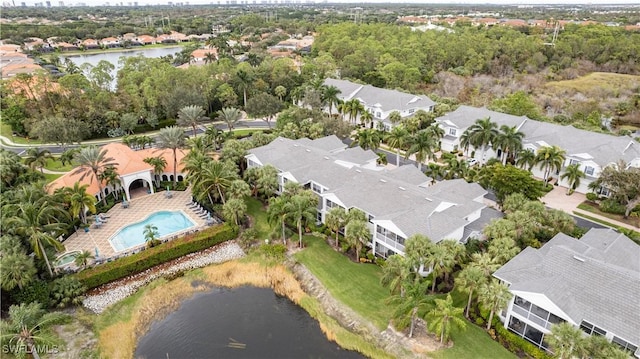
246, 136, 496, 257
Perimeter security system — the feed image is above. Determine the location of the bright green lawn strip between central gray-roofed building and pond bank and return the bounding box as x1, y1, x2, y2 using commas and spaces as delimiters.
295, 236, 390, 330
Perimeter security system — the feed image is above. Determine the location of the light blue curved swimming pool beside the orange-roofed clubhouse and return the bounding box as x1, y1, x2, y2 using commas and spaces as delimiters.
109, 211, 196, 252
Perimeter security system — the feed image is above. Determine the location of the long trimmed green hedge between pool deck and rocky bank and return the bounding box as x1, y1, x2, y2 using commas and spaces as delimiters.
76, 224, 238, 289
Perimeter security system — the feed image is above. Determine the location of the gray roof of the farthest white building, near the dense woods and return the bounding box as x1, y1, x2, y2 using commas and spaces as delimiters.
324, 79, 436, 117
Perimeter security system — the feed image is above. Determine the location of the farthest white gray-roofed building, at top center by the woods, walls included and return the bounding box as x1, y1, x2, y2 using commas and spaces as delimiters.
324, 79, 435, 130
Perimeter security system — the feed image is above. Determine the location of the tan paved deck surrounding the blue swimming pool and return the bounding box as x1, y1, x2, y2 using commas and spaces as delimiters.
63, 189, 206, 259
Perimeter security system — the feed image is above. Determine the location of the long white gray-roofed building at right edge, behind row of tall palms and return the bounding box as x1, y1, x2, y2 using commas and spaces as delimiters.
436, 106, 640, 195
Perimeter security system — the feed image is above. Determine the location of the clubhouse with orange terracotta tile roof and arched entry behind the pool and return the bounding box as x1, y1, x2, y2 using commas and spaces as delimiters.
47, 143, 187, 204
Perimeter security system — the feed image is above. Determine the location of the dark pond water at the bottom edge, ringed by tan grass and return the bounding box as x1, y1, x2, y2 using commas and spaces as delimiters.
135, 287, 364, 359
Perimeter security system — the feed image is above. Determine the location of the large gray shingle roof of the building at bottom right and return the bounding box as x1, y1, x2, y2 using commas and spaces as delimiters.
494, 229, 640, 345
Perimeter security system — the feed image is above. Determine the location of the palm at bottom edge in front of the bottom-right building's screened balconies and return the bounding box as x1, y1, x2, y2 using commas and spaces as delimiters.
545, 322, 588, 359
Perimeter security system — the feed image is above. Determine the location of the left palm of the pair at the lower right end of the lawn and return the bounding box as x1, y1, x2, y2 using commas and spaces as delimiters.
387, 280, 432, 338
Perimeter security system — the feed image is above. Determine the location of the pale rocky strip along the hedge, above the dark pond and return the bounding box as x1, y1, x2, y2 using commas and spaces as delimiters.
82, 241, 245, 314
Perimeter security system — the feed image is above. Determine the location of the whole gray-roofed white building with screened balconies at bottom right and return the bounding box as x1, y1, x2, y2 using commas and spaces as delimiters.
493, 229, 640, 357
